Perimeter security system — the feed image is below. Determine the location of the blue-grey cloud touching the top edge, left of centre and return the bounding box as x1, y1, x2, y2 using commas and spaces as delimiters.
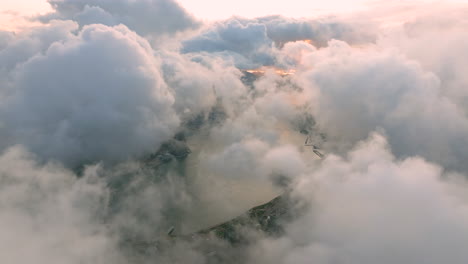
40, 0, 199, 36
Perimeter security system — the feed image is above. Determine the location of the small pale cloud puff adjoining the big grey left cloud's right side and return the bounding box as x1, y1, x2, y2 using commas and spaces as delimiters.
156, 50, 247, 117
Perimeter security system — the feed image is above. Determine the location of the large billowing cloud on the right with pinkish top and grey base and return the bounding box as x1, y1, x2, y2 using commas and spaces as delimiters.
299, 38, 468, 171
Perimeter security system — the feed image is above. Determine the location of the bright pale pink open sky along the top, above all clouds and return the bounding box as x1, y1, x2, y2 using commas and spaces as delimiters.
0, 0, 468, 31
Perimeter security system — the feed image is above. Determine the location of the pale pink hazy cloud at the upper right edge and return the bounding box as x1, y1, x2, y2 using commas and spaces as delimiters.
379, 5, 468, 114
